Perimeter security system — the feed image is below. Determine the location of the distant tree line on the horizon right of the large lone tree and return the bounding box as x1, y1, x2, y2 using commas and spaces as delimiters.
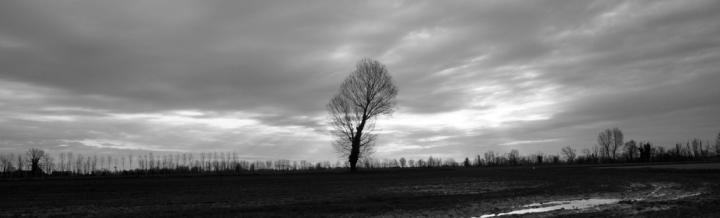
360, 127, 720, 168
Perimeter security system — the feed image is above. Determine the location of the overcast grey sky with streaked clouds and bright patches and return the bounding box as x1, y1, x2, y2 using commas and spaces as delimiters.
0, 0, 720, 162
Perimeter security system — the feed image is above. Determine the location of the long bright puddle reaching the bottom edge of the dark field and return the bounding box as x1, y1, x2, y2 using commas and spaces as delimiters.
480, 199, 620, 218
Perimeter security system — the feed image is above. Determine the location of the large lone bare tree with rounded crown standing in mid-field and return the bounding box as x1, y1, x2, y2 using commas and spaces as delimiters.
326, 59, 398, 172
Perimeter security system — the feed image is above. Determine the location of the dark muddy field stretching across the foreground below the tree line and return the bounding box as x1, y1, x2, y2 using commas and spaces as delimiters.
0, 166, 720, 217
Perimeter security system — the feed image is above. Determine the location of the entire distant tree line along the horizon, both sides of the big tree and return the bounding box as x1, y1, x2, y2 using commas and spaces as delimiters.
0, 128, 720, 178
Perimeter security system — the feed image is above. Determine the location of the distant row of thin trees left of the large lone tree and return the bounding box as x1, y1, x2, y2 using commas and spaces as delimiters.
0, 151, 349, 178
